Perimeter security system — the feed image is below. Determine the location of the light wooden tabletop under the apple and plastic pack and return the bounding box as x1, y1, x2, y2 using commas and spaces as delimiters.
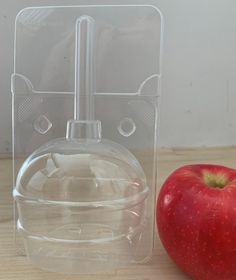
0, 148, 236, 280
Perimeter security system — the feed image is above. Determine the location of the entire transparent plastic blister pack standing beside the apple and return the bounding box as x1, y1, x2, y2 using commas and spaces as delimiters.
11, 5, 162, 273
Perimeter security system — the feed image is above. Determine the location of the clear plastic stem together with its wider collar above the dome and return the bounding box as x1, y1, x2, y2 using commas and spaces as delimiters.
66, 15, 101, 141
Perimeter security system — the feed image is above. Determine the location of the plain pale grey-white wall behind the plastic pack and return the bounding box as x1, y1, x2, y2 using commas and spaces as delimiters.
0, 0, 236, 153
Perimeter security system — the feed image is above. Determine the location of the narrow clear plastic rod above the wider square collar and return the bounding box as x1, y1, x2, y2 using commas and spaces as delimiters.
74, 16, 95, 121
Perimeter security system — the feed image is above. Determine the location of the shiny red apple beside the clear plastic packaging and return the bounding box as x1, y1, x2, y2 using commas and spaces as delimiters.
156, 164, 236, 280
